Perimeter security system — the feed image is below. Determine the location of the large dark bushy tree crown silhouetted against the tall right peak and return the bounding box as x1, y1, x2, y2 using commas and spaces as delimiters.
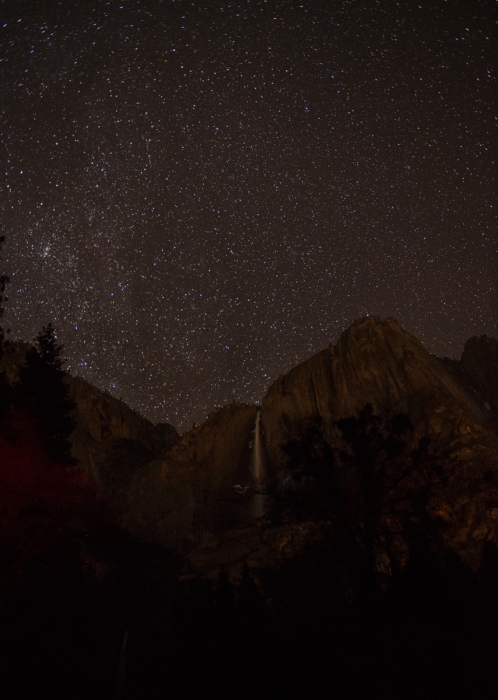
275, 404, 454, 575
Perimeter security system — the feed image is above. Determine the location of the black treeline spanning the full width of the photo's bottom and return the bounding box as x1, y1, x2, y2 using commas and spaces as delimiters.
2, 528, 498, 700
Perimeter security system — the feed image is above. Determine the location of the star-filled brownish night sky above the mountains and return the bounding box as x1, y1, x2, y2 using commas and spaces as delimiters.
0, 0, 498, 429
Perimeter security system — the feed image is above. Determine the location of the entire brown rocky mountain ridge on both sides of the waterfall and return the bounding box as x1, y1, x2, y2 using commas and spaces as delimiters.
4, 316, 498, 572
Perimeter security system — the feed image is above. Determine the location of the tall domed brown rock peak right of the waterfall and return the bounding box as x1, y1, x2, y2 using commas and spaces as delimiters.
261, 317, 498, 565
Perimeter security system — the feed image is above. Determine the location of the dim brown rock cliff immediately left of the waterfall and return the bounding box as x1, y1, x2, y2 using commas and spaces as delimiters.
115, 403, 257, 550
